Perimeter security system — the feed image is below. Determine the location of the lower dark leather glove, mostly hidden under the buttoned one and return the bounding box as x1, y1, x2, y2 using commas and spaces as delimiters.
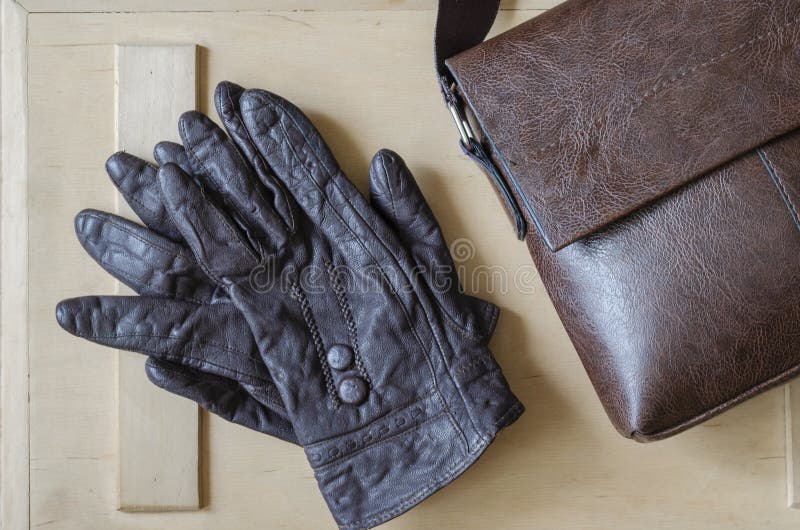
56, 147, 297, 443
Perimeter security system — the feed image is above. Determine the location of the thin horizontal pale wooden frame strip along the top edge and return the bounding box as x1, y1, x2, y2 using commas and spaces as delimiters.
19, 0, 561, 13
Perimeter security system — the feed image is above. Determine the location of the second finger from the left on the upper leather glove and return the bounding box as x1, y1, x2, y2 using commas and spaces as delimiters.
179, 111, 289, 248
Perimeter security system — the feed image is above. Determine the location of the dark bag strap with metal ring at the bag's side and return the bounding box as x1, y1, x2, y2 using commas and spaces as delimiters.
433, 0, 528, 240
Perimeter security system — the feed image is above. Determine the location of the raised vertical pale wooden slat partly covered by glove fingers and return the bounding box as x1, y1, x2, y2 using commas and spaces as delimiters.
115, 45, 200, 511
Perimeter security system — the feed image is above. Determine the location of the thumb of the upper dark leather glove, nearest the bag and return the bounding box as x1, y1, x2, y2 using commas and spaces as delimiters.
369, 149, 499, 337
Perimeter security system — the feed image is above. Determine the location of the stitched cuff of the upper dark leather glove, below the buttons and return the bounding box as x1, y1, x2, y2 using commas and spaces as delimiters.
306, 382, 524, 530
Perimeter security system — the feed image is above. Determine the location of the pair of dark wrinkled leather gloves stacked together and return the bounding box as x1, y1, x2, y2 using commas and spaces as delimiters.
56, 82, 523, 530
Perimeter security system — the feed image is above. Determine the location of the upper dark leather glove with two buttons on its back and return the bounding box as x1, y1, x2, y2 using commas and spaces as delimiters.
158, 84, 523, 530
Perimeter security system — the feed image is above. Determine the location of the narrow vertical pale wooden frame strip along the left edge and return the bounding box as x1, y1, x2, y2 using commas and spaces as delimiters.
0, 0, 30, 529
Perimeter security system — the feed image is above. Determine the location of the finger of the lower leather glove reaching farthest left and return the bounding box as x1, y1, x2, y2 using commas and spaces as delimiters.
56, 296, 273, 386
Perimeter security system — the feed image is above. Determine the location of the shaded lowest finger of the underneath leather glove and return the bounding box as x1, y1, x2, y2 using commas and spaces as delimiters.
145, 357, 298, 444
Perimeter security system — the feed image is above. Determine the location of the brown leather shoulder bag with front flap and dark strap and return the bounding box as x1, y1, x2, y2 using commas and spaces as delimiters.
436, 0, 800, 441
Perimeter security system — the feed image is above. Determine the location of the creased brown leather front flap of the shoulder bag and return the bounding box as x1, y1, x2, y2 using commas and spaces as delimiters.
447, 0, 800, 250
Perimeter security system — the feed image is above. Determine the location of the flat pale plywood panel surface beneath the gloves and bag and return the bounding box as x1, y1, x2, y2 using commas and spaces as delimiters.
17, 5, 800, 530
